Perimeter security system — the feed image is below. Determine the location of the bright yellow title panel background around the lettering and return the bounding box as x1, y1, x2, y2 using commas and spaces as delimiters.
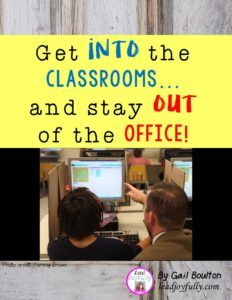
0, 35, 232, 148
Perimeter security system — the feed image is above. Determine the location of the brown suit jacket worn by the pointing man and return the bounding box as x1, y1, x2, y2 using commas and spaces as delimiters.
134, 230, 192, 260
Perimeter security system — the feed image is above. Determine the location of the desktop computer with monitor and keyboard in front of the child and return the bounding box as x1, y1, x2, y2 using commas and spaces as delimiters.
68, 156, 139, 244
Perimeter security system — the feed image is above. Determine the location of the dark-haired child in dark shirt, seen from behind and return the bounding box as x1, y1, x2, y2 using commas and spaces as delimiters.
48, 188, 151, 260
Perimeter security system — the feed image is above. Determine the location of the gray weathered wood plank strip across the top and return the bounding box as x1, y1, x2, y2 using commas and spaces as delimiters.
0, 0, 232, 34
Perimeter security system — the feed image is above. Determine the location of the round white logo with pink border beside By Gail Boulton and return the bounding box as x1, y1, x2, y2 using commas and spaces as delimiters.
126, 267, 154, 295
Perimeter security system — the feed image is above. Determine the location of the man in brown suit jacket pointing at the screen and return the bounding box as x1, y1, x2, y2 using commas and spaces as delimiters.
125, 182, 192, 260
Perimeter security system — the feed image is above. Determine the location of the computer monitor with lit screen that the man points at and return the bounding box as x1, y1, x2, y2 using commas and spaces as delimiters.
69, 157, 125, 202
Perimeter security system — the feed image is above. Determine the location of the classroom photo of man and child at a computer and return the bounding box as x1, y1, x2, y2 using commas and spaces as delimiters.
40, 148, 193, 260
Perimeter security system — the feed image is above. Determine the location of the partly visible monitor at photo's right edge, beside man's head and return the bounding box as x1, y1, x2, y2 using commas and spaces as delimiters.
171, 157, 192, 200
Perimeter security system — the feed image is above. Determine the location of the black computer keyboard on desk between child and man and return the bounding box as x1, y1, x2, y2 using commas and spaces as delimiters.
94, 231, 139, 244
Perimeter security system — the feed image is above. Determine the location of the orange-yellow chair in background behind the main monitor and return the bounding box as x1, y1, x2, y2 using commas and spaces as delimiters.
128, 165, 148, 190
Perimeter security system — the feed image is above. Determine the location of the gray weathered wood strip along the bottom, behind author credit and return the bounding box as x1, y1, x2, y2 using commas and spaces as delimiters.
0, 261, 232, 300
